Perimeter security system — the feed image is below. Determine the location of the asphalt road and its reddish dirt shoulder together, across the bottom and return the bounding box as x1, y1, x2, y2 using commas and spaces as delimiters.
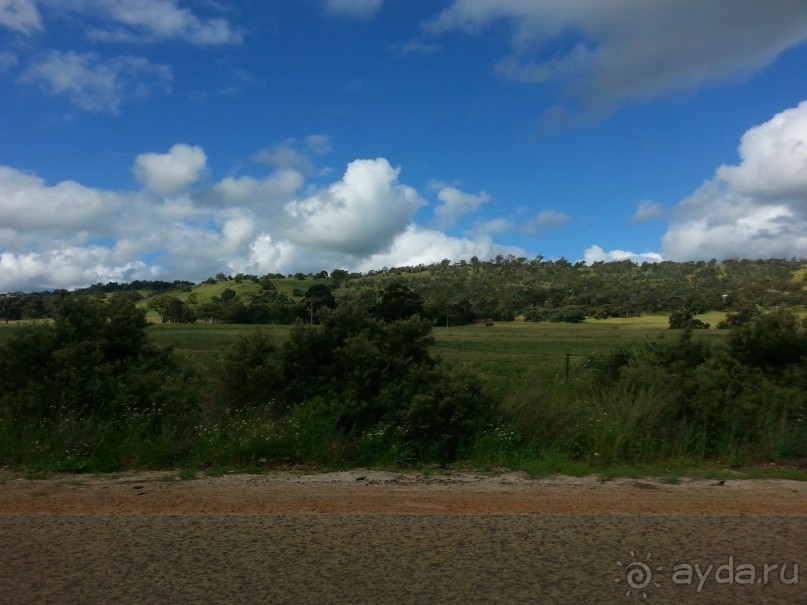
0, 470, 807, 605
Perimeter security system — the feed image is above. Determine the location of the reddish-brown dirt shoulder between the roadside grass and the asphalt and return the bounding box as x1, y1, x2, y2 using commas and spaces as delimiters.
0, 469, 807, 514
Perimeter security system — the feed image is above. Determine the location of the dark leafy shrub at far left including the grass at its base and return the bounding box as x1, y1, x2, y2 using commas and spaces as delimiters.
0, 298, 197, 470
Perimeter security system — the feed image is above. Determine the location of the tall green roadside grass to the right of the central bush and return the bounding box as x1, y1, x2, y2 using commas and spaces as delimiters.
473, 360, 807, 469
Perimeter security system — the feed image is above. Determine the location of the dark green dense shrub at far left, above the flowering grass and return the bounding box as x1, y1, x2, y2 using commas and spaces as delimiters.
0, 298, 194, 419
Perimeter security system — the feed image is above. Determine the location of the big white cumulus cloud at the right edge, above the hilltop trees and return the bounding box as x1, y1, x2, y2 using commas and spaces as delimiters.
662, 101, 807, 260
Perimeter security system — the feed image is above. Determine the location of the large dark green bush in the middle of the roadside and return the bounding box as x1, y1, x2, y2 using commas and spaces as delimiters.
208, 304, 496, 461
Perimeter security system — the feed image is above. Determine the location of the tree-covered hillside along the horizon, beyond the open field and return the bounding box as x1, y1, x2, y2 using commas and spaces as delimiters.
0, 256, 807, 326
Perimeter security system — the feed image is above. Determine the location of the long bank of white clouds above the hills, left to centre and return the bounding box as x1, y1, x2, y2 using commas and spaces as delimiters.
0, 145, 523, 292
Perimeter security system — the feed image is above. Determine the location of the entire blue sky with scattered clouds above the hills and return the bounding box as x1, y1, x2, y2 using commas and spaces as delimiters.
0, 0, 807, 292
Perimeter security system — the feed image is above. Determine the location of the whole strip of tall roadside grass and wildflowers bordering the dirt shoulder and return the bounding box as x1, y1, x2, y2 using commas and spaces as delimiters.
0, 379, 807, 475
